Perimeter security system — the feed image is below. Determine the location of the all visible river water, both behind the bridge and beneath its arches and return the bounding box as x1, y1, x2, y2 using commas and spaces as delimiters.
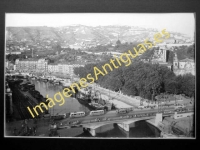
31, 81, 159, 138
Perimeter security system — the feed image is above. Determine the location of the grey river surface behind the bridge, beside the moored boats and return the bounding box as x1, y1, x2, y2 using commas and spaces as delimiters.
31, 81, 89, 114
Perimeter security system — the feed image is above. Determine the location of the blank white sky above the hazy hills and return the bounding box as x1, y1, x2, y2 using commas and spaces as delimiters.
6, 13, 196, 37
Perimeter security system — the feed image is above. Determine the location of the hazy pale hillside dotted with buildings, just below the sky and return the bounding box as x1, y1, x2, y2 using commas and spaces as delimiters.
6, 25, 194, 50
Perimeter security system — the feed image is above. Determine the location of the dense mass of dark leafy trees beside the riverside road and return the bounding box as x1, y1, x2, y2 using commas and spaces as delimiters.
74, 60, 195, 99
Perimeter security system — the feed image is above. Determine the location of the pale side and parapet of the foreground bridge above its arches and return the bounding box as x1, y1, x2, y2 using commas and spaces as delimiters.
59, 110, 193, 129
